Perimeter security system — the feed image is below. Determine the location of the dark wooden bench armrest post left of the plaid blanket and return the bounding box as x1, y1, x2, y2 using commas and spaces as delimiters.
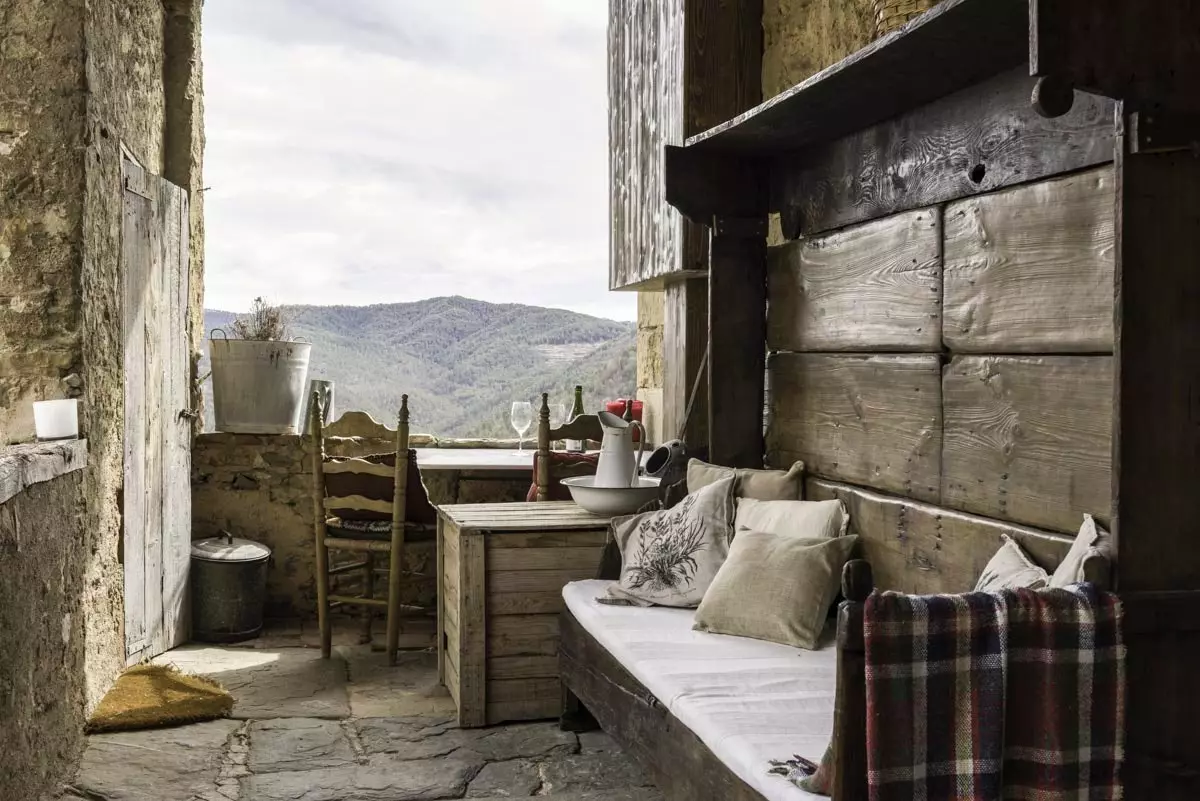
833, 559, 875, 801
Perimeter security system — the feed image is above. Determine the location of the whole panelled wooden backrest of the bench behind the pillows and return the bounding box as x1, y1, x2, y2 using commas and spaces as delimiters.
767, 165, 1116, 582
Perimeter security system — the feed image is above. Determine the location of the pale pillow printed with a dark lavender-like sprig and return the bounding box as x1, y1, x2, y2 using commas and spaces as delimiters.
607, 478, 733, 607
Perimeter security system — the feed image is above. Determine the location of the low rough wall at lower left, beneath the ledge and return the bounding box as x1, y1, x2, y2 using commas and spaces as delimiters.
0, 471, 89, 801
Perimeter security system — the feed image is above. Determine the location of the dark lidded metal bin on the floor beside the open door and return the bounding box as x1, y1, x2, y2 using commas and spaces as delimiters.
192, 531, 271, 643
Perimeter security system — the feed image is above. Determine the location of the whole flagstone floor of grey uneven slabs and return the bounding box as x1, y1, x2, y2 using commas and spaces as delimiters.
62, 627, 662, 801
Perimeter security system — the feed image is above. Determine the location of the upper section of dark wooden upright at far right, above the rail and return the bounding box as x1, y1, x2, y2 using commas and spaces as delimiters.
1114, 145, 1200, 594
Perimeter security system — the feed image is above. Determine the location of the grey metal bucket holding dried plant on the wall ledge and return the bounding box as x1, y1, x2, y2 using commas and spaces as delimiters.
209, 329, 312, 434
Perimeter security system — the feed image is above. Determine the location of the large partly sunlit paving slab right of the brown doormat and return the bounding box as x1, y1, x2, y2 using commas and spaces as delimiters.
154, 645, 350, 719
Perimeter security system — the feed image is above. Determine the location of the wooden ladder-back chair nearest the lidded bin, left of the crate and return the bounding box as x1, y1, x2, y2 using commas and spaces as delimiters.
308, 392, 437, 664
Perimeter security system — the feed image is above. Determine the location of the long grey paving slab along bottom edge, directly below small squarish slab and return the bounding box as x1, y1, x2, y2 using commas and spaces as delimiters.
241, 757, 481, 801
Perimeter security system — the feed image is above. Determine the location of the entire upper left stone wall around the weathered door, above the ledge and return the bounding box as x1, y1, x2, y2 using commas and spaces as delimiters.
0, 0, 203, 704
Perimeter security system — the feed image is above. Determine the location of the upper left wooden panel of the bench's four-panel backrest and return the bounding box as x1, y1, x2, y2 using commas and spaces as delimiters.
767, 209, 942, 353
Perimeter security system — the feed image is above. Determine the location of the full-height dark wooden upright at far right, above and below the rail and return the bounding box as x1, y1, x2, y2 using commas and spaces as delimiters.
1112, 112, 1200, 801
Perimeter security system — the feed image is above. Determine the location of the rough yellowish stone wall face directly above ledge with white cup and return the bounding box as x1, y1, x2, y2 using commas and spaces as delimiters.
0, 0, 84, 445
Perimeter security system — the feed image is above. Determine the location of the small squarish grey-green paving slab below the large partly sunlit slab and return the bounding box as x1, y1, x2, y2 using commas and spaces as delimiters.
247, 717, 354, 773
